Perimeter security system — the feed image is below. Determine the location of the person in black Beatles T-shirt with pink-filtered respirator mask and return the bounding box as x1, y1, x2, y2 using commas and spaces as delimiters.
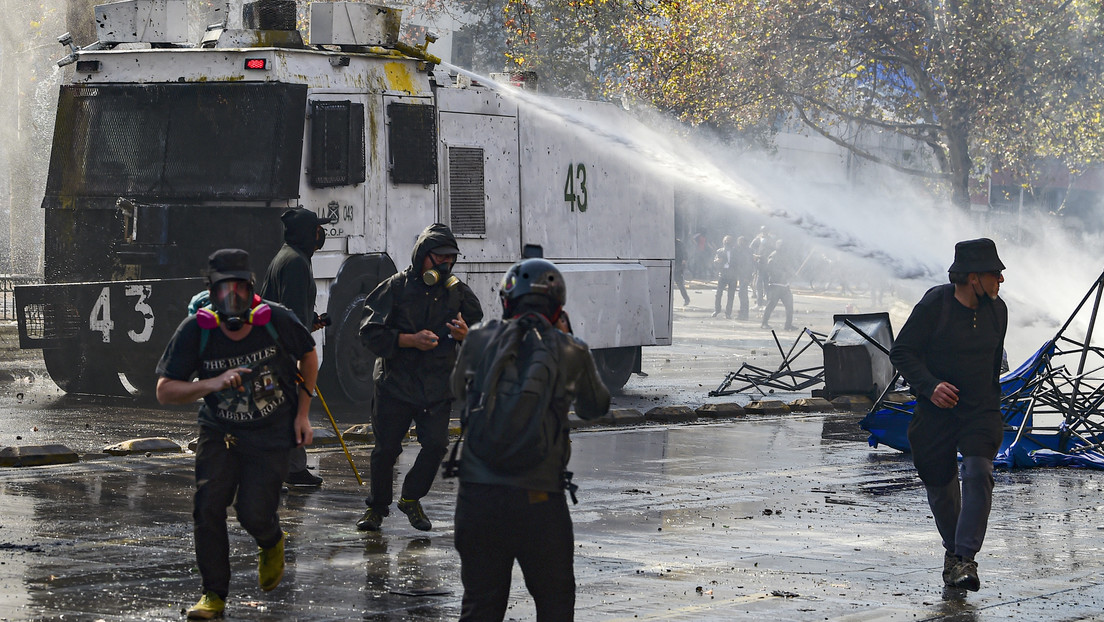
157, 249, 318, 620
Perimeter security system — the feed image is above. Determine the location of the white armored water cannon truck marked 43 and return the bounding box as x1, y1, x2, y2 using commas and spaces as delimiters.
15, 0, 675, 403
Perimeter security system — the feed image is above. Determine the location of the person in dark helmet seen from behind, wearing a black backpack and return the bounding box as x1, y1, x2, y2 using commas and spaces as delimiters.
447, 259, 609, 621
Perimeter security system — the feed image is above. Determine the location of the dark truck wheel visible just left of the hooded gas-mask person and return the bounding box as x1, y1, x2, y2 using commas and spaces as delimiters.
322, 294, 375, 412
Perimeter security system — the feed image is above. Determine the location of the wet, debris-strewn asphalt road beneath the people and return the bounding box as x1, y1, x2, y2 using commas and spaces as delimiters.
0, 285, 1104, 621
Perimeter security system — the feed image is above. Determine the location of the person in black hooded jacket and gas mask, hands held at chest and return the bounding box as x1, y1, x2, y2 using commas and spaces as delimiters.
357, 223, 482, 531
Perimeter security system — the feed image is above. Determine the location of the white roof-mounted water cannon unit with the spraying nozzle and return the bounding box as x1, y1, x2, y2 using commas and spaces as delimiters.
310, 2, 440, 65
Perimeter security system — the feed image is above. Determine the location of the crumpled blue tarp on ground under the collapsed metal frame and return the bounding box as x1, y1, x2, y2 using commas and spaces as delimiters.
859, 340, 1104, 471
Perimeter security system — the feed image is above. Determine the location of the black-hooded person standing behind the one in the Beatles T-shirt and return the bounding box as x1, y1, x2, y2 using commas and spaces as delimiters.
257, 208, 332, 486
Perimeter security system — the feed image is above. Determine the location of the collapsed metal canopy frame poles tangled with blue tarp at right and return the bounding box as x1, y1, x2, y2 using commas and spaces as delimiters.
868, 272, 1104, 461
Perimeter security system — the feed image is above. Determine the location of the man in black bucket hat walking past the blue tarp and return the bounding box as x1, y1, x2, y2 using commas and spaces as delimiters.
890, 238, 1008, 591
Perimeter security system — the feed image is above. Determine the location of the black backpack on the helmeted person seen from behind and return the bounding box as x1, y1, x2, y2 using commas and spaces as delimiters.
446, 314, 563, 473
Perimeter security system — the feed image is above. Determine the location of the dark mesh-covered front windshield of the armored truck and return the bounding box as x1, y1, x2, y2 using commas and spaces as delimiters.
46, 83, 307, 205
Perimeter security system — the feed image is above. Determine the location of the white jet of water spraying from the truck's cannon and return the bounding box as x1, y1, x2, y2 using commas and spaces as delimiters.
443, 67, 1102, 368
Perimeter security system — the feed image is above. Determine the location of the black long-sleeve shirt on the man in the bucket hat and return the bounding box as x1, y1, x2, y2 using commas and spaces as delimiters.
890, 284, 1008, 413
